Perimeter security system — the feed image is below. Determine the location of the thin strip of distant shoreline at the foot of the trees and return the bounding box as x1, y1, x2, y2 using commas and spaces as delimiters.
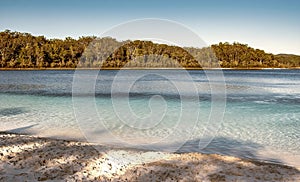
0, 67, 300, 71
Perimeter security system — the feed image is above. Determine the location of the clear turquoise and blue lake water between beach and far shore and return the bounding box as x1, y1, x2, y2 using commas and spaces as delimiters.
0, 70, 300, 167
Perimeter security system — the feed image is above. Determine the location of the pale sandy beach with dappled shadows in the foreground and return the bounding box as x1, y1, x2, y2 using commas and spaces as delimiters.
0, 133, 300, 181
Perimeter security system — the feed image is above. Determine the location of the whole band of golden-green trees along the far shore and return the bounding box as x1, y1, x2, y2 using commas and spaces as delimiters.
0, 30, 300, 68
